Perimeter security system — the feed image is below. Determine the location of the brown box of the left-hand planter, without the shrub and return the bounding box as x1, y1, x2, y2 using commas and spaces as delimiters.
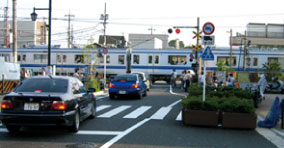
182, 109, 219, 127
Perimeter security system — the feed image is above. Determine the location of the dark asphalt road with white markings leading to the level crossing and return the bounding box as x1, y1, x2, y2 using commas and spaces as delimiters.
0, 84, 276, 148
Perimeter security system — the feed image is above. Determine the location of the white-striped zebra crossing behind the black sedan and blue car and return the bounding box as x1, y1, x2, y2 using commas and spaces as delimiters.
97, 105, 181, 121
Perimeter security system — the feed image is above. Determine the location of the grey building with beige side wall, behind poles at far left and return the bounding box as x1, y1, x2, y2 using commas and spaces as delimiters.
0, 21, 47, 48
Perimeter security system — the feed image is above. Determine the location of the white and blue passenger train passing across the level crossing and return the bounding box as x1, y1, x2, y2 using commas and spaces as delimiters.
0, 47, 284, 82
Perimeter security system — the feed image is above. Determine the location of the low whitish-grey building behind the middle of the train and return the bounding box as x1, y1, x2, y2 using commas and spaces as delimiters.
128, 34, 169, 49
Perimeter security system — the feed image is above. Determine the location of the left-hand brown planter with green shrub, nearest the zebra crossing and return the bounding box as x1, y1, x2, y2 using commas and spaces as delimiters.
182, 96, 219, 127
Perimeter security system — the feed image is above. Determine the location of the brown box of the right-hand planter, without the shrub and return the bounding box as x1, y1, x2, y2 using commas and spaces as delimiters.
223, 112, 257, 129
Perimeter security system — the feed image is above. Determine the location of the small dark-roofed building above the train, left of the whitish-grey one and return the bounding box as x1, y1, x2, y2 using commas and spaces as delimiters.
99, 35, 126, 48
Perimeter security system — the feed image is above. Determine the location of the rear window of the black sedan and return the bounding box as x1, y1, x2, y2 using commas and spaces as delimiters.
15, 78, 68, 93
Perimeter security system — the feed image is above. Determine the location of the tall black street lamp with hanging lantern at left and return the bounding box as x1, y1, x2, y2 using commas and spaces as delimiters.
31, 0, 52, 75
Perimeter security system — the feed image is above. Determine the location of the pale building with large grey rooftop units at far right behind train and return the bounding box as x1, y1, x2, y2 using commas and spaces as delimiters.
232, 23, 284, 48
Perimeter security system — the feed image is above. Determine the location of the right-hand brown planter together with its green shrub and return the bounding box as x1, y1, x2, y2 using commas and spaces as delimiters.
219, 97, 257, 129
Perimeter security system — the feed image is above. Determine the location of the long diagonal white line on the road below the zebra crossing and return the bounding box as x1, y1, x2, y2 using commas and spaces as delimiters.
100, 118, 150, 148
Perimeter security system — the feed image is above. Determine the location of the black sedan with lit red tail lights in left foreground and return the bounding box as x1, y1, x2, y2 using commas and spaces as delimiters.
0, 76, 96, 132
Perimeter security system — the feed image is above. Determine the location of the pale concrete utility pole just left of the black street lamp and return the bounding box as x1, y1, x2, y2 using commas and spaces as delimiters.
13, 0, 18, 63
